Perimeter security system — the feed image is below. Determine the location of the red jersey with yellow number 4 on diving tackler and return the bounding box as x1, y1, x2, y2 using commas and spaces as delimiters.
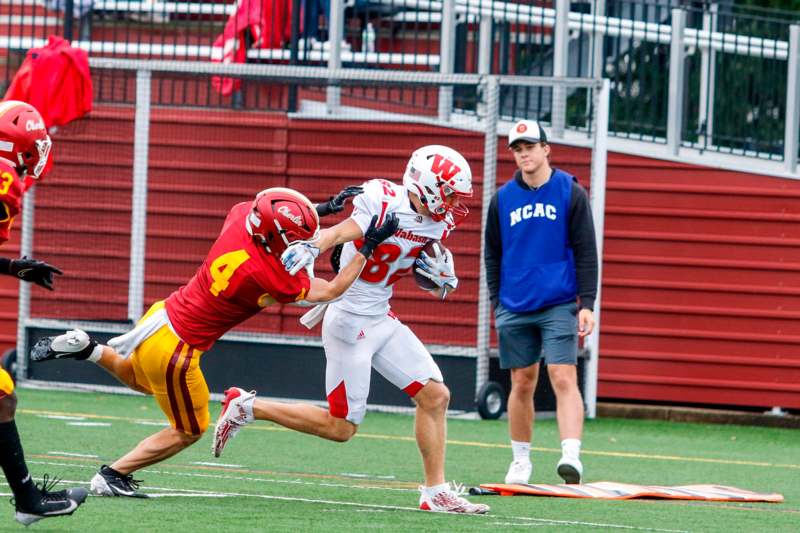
166, 202, 311, 351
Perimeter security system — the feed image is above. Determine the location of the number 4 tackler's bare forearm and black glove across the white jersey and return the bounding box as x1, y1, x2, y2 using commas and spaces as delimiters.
306, 214, 400, 303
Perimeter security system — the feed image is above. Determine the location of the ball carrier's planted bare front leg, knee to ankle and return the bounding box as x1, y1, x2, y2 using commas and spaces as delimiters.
414, 380, 450, 487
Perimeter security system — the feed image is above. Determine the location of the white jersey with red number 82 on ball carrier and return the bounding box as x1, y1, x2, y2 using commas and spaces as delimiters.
332, 179, 454, 315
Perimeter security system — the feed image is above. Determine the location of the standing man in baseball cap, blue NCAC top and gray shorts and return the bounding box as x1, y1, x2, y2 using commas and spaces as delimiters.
485, 120, 598, 484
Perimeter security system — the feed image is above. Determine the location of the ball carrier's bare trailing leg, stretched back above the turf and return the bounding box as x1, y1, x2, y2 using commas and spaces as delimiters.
253, 399, 358, 442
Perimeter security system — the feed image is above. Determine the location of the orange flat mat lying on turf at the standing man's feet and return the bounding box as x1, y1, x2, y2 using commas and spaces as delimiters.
481, 481, 783, 503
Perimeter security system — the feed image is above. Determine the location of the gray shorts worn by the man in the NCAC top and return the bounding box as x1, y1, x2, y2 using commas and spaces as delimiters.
494, 302, 578, 368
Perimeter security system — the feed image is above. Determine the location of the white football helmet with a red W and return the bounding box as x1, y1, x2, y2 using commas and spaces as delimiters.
403, 144, 472, 222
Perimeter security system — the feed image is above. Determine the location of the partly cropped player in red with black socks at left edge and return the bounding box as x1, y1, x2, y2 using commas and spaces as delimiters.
0, 100, 87, 525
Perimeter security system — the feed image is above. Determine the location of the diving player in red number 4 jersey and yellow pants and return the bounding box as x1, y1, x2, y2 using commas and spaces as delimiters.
31, 187, 397, 497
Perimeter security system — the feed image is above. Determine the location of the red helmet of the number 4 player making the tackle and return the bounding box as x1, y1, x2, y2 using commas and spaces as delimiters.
246, 187, 319, 256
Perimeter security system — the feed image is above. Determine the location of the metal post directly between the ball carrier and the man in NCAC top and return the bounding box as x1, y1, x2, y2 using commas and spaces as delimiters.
475, 76, 500, 397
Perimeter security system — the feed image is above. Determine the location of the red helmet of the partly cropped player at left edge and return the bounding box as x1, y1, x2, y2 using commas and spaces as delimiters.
0, 100, 52, 179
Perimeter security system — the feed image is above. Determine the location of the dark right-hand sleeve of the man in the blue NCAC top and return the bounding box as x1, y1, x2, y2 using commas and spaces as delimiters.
569, 182, 597, 310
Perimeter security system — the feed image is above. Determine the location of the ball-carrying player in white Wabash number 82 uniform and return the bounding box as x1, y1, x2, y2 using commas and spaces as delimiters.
214, 145, 489, 514
